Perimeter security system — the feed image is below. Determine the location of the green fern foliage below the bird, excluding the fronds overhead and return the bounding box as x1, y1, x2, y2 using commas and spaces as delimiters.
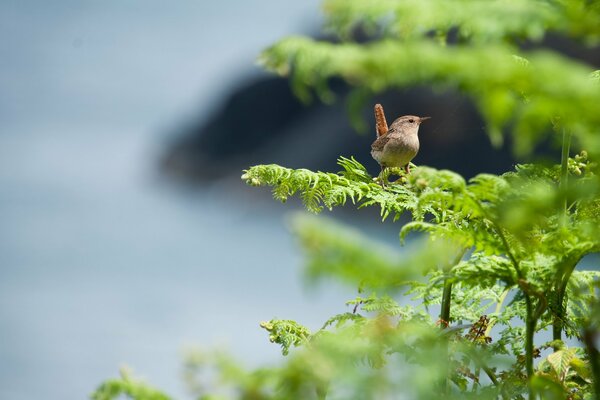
200, 153, 600, 398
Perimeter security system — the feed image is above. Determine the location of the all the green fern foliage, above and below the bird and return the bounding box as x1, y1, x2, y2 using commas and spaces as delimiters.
94, 0, 600, 399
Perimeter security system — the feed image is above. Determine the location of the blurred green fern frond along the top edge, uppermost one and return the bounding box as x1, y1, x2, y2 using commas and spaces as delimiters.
324, 0, 600, 42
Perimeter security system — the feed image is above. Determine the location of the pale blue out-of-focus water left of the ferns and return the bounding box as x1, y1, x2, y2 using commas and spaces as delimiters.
0, 0, 366, 400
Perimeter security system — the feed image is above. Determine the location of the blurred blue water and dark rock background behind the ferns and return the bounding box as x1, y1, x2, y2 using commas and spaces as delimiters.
0, 0, 599, 400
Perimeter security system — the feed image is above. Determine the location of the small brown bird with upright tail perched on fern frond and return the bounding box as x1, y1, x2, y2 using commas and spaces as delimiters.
371, 104, 430, 173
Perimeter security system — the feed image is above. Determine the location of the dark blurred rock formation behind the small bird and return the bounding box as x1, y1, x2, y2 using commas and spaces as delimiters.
162, 77, 513, 182
